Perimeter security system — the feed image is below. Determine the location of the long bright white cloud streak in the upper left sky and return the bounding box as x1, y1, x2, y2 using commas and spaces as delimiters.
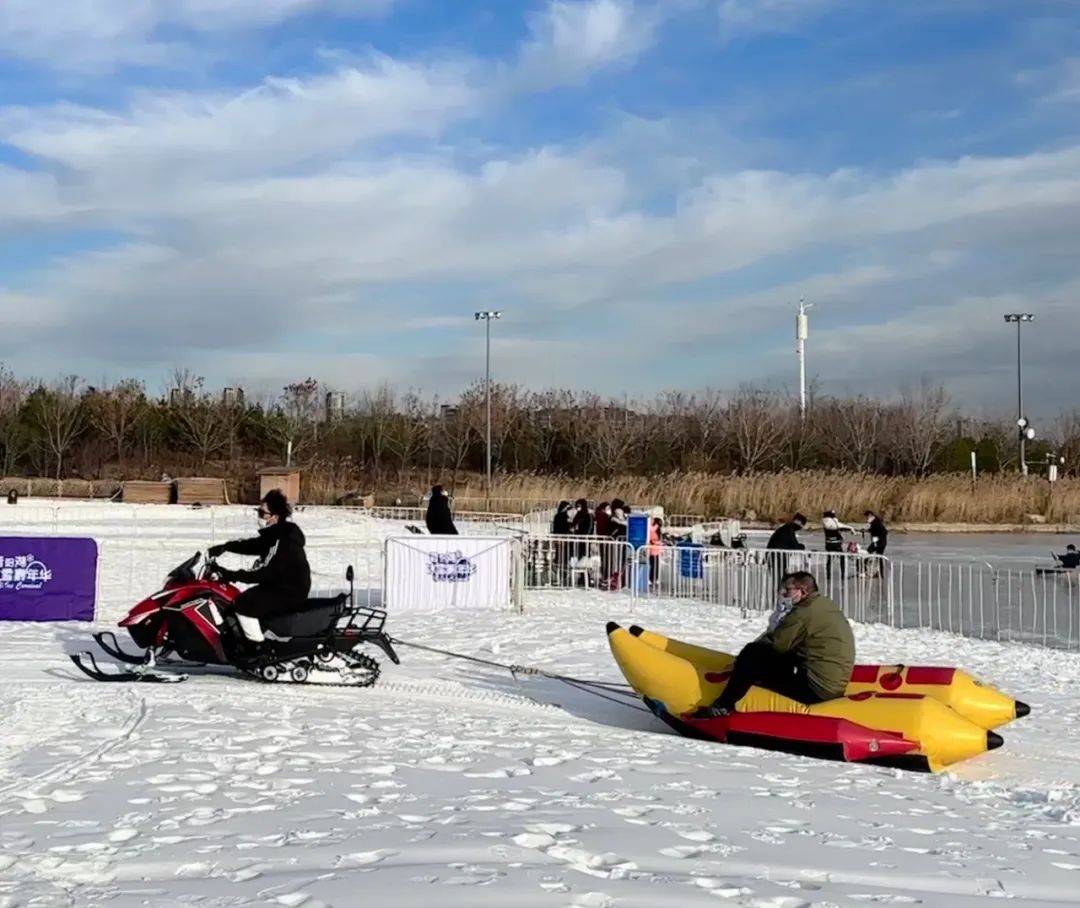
0, 56, 478, 182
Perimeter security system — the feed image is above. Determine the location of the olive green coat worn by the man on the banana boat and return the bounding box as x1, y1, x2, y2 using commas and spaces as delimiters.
764, 593, 855, 700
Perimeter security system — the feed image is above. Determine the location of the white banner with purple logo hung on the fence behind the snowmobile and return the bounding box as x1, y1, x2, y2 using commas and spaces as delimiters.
382, 536, 514, 614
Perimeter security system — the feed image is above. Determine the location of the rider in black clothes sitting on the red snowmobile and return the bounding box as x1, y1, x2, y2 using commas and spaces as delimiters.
206, 489, 311, 642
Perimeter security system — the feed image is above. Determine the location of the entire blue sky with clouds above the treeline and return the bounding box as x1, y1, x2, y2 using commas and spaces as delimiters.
0, 0, 1080, 414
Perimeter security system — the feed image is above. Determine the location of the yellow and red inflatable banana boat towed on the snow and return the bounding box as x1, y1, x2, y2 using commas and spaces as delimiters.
607, 622, 1029, 772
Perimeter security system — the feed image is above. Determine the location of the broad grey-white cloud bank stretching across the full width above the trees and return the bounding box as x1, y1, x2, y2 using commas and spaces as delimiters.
0, 38, 1080, 405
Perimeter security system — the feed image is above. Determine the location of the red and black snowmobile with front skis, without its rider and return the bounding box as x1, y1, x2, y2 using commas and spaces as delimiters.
71, 552, 399, 687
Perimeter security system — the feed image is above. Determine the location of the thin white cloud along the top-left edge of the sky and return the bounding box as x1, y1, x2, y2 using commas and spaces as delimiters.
0, 0, 395, 70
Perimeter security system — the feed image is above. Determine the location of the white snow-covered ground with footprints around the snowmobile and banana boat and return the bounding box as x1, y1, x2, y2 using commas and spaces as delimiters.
6, 512, 1080, 908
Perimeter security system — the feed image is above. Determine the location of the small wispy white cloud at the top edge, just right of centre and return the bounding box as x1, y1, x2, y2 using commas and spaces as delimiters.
518, 0, 658, 87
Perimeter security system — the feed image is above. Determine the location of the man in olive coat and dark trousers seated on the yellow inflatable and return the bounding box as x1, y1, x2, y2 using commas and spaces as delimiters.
693, 571, 855, 719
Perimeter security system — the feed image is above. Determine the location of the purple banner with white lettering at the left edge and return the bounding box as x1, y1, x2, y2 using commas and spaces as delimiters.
0, 536, 97, 621
